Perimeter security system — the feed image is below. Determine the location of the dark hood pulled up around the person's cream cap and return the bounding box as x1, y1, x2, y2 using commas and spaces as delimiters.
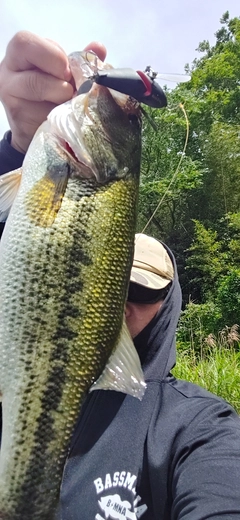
134, 242, 182, 381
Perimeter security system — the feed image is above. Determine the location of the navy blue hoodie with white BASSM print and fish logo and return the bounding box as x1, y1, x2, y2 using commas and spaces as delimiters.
0, 132, 240, 520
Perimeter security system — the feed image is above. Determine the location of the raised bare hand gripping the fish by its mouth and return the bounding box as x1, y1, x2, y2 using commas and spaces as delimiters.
0, 31, 106, 153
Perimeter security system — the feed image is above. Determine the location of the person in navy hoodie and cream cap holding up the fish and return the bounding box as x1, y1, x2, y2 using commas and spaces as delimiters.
0, 32, 240, 520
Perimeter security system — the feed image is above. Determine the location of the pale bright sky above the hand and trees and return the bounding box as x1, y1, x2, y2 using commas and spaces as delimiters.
0, 0, 240, 138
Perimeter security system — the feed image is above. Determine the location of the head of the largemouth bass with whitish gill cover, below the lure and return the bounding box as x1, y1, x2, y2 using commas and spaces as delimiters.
48, 83, 142, 184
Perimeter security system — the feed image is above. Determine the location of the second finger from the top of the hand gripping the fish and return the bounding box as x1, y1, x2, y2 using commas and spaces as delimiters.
5, 70, 74, 104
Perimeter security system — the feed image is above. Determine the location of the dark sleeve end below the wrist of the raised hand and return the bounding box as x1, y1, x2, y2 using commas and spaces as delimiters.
0, 131, 24, 175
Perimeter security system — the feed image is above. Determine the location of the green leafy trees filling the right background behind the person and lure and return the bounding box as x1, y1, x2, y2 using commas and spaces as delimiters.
138, 12, 240, 316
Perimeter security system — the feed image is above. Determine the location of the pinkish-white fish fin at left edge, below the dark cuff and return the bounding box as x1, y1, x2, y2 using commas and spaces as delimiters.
0, 168, 22, 222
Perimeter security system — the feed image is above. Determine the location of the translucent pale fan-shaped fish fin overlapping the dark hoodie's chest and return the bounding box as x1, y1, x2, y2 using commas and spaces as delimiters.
90, 319, 146, 400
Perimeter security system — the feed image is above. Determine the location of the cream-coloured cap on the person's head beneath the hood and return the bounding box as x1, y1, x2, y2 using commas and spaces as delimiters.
130, 233, 174, 289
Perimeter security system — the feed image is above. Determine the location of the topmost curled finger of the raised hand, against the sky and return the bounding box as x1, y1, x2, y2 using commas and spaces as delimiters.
5, 31, 71, 79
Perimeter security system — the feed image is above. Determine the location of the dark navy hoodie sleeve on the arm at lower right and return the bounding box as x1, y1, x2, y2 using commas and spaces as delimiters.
171, 400, 240, 520
